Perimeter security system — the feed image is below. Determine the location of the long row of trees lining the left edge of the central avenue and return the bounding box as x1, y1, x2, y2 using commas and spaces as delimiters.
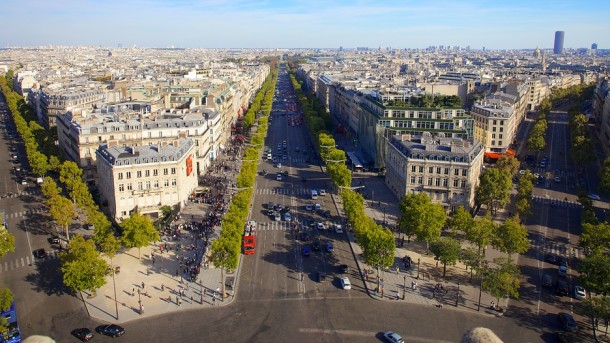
210, 68, 277, 296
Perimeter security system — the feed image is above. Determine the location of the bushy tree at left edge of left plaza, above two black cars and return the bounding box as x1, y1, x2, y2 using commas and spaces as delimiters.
59, 235, 108, 301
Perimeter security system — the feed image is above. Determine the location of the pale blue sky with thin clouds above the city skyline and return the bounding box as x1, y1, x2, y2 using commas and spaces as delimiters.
0, 0, 610, 49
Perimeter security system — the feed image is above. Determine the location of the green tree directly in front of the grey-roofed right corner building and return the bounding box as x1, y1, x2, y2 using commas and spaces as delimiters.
398, 193, 447, 249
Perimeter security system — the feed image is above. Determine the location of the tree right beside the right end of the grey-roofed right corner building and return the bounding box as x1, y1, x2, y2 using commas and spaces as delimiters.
476, 168, 513, 213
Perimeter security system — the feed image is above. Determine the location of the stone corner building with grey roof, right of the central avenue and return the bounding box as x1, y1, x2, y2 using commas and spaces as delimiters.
385, 133, 483, 211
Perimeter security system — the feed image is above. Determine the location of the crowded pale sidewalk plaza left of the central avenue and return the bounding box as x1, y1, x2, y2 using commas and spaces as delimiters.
81, 141, 245, 323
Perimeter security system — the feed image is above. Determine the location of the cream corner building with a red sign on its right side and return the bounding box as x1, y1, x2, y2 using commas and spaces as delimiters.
95, 138, 198, 221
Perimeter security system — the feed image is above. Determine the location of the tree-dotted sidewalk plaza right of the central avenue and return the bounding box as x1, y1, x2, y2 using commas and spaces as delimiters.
331, 177, 508, 315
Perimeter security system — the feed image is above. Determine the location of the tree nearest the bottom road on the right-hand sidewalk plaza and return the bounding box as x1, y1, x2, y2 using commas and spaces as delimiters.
482, 258, 521, 303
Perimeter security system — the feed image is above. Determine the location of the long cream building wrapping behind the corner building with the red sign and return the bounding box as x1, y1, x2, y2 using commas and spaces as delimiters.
57, 102, 223, 185
